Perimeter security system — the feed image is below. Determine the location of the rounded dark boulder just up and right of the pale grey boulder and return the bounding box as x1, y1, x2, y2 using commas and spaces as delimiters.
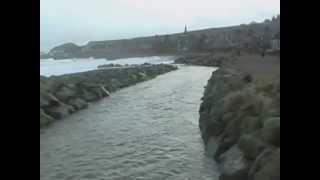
238, 134, 267, 160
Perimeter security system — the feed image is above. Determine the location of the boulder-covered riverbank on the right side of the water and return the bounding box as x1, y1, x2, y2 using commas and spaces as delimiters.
199, 55, 280, 180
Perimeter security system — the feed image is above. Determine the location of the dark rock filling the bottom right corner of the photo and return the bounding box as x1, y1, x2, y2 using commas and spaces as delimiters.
254, 149, 280, 180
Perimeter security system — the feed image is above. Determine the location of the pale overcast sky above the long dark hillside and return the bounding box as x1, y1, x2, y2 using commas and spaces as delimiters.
40, 0, 280, 50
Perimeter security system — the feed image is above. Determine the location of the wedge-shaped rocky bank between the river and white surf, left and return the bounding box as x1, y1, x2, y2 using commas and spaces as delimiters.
40, 64, 177, 127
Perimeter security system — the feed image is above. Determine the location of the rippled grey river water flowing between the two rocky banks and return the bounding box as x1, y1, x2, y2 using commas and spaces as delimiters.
40, 65, 219, 180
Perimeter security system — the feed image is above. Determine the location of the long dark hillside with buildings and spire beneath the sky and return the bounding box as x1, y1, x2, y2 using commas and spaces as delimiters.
40, 15, 280, 59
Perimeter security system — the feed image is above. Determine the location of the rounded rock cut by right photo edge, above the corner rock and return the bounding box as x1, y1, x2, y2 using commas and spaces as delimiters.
258, 117, 280, 147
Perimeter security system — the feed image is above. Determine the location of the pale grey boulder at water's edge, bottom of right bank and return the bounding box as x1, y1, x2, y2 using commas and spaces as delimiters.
219, 145, 248, 180
